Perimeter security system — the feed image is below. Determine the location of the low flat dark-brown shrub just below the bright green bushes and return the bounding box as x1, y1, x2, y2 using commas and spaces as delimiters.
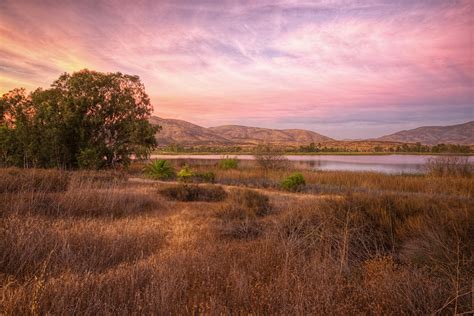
158, 184, 227, 202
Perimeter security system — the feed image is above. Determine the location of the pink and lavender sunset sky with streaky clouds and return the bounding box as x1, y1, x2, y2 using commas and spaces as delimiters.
0, 0, 474, 139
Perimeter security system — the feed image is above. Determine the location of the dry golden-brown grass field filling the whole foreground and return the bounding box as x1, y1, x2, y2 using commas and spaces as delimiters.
0, 165, 474, 315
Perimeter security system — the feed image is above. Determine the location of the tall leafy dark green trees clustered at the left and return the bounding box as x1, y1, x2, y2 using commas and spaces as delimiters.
0, 70, 159, 169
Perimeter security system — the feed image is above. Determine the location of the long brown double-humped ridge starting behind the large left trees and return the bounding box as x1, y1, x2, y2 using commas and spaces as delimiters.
150, 116, 333, 146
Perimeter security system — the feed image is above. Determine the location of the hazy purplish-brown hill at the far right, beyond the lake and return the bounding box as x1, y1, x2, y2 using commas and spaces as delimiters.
376, 121, 474, 145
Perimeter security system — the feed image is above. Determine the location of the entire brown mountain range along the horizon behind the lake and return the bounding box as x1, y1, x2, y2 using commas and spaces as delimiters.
150, 116, 474, 146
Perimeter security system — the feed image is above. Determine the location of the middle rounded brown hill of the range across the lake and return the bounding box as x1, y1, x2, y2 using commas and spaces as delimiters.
209, 125, 333, 145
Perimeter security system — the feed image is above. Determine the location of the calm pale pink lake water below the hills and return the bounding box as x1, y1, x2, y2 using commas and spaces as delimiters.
151, 155, 474, 173
